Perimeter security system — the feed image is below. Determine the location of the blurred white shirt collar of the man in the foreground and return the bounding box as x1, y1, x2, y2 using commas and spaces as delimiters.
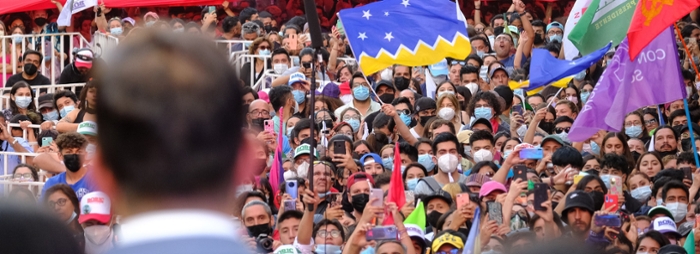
118, 209, 238, 246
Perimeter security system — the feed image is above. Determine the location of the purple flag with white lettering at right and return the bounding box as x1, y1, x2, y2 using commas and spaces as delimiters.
569, 28, 687, 142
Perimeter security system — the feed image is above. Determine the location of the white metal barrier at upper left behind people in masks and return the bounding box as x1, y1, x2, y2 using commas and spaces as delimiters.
0, 33, 89, 87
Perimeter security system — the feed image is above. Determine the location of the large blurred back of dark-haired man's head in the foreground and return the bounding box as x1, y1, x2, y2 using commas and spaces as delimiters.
93, 30, 246, 201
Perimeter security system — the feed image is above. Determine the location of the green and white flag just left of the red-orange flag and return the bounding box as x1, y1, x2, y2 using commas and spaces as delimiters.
569, 0, 638, 56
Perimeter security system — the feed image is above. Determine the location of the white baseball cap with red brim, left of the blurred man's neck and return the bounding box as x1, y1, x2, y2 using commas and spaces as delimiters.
78, 191, 112, 224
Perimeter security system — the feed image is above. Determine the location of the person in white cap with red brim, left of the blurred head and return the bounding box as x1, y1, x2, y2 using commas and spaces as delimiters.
78, 191, 116, 254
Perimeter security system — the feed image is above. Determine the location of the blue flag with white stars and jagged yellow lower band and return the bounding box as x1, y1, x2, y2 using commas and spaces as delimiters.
338, 0, 471, 75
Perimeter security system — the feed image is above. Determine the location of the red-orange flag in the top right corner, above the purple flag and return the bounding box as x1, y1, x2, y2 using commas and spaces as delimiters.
627, 0, 700, 60
